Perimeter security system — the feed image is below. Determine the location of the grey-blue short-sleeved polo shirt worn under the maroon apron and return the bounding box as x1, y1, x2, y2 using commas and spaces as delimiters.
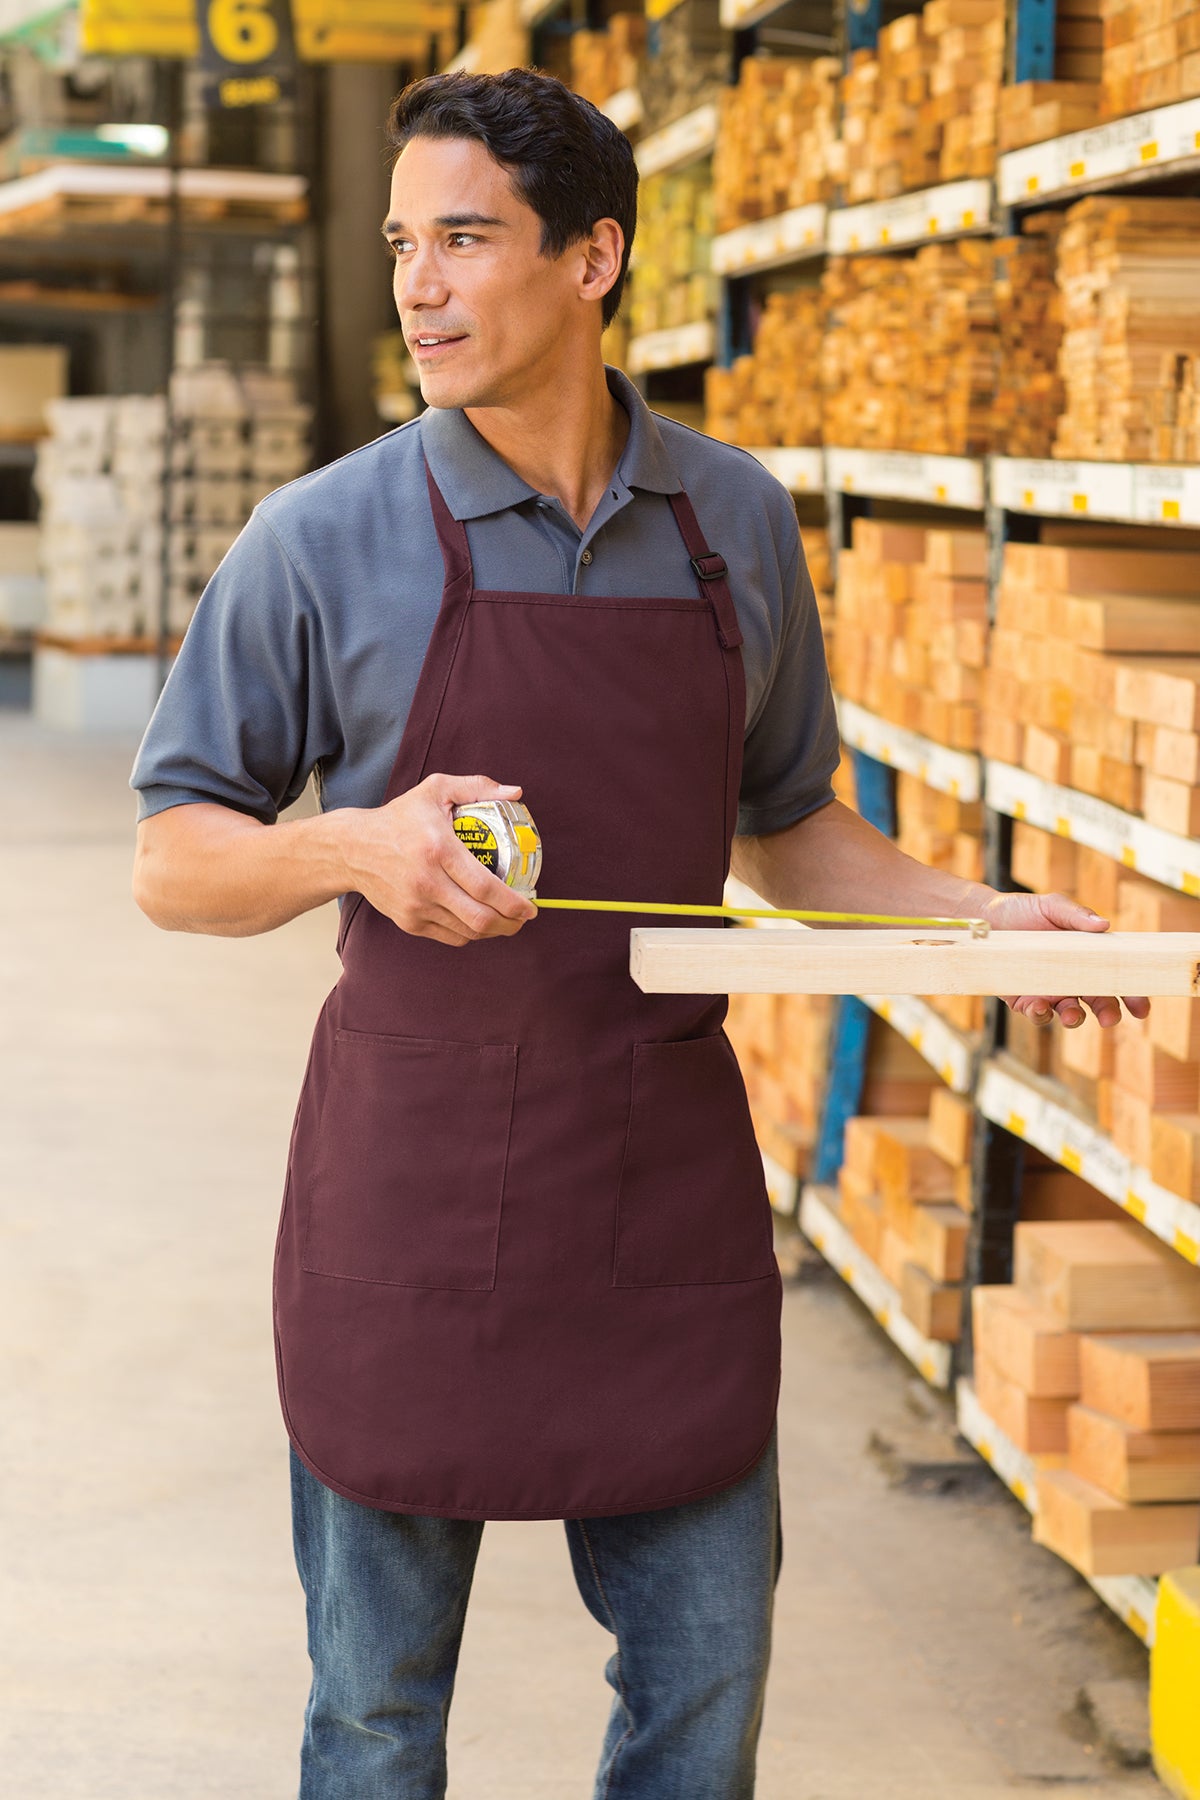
131, 369, 838, 835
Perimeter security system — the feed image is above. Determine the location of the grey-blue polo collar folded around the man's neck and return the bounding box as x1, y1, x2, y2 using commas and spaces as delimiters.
421, 365, 682, 520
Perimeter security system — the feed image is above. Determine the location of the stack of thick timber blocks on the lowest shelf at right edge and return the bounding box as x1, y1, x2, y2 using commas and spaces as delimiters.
972, 1219, 1200, 1575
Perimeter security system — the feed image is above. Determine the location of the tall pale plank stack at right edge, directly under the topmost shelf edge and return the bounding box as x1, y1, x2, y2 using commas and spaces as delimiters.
1054, 196, 1200, 463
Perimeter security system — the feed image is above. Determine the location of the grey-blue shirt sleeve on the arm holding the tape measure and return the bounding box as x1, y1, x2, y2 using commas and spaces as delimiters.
130, 511, 338, 824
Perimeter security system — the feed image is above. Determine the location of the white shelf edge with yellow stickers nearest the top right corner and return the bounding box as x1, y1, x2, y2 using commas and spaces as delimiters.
997, 99, 1200, 205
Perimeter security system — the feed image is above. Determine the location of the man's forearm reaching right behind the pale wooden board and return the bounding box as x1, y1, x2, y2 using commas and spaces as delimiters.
732, 799, 995, 918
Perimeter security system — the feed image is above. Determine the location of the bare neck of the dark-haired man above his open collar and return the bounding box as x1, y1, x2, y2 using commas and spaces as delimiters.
464, 358, 630, 531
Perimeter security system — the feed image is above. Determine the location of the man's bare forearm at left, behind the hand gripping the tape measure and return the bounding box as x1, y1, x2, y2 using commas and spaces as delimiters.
133, 803, 353, 938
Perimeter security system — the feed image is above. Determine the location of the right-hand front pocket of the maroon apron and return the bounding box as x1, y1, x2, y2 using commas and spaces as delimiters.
613, 1033, 775, 1287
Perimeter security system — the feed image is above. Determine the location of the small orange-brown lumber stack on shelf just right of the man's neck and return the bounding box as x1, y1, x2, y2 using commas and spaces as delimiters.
703, 288, 824, 445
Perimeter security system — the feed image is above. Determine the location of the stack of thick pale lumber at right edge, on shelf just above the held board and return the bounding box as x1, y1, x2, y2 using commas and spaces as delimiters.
982, 529, 1200, 820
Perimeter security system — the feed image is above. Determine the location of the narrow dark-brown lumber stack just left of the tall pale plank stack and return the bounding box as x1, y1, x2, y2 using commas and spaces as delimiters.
991, 212, 1063, 457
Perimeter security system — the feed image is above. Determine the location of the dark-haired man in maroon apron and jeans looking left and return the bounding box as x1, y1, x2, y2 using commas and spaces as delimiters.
133, 70, 1144, 1800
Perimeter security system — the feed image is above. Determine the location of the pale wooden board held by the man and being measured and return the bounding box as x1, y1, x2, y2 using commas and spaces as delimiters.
630, 927, 1200, 995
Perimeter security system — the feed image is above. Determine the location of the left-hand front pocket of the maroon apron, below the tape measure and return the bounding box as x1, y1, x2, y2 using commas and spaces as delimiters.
300, 1031, 516, 1287
